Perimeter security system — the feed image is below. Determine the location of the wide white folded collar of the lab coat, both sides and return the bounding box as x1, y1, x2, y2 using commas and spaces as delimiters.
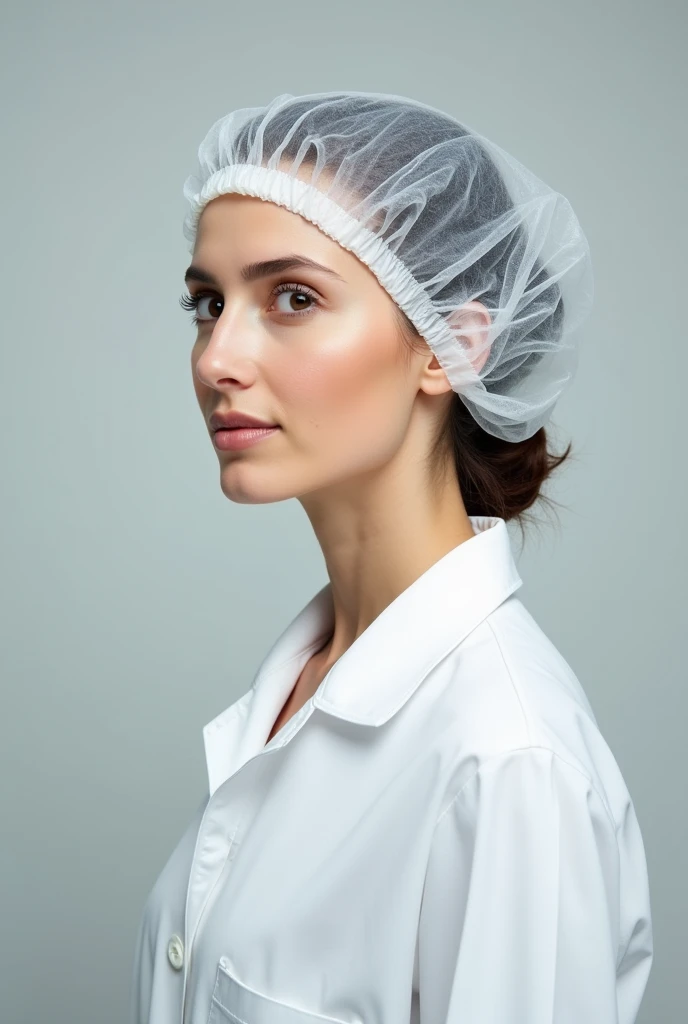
204, 516, 522, 795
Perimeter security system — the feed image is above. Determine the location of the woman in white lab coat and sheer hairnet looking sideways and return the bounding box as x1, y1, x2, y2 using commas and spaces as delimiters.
131, 92, 652, 1024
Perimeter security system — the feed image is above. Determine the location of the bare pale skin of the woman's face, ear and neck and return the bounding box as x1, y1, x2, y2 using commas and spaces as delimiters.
187, 194, 489, 740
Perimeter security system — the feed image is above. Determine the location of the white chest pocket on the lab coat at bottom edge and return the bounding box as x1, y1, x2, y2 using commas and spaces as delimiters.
208, 956, 351, 1024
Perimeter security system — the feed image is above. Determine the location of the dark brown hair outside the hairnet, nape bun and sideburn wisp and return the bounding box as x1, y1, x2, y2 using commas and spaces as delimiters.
395, 306, 575, 537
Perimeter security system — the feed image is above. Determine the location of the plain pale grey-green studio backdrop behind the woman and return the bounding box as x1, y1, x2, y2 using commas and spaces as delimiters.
0, 0, 688, 1024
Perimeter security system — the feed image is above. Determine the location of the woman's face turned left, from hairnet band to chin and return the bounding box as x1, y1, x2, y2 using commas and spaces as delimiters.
187, 194, 436, 504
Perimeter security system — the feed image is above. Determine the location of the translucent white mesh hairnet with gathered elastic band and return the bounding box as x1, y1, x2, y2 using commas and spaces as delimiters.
183, 91, 593, 441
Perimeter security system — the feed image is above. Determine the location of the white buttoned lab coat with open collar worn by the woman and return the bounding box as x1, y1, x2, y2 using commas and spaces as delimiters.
130, 516, 652, 1024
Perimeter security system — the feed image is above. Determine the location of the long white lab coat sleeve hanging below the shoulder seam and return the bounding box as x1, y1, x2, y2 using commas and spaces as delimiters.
418, 748, 635, 1024
